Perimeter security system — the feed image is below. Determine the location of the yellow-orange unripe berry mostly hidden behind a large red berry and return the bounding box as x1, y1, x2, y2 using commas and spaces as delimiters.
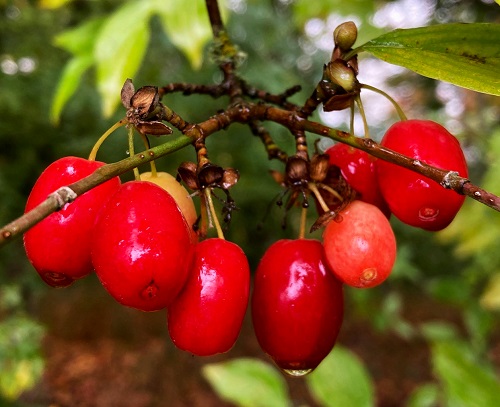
140, 172, 198, 241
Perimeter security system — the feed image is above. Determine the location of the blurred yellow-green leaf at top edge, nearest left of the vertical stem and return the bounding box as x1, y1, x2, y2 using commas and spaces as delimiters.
156, 0, 226, 69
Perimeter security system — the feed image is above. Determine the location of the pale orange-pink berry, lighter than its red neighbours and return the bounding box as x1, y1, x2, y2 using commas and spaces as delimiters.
323, 201, 396, 288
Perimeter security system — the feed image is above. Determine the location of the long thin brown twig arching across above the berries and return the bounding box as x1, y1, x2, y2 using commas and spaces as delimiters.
0, 103, 500, 247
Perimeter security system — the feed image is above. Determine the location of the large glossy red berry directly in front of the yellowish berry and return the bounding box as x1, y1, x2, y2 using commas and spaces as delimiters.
92, 181, 194, 311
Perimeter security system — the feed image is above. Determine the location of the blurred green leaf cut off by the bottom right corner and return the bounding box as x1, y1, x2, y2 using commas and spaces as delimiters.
432, 341, 500, 407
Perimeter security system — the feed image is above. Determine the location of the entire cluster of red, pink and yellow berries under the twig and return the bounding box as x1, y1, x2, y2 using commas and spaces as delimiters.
24, 120, 467, 376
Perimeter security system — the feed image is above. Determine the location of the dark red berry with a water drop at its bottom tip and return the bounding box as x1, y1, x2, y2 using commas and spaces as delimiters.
251, 239, 344, 376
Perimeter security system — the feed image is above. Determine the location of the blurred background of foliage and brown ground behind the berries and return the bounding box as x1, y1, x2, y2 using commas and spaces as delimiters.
0, 0, 500, 407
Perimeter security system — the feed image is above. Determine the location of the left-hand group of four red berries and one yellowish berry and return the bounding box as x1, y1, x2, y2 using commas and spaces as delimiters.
24, 157, 250, 356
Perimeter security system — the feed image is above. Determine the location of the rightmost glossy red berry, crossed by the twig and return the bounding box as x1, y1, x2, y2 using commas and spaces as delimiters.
377, 120, 468, 231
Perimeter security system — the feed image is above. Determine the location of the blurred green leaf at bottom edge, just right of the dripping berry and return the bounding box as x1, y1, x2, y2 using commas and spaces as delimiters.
306, 345, 375, 407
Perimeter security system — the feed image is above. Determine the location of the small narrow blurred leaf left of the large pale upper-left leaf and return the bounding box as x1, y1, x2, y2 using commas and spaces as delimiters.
50, 55, 94, 124
